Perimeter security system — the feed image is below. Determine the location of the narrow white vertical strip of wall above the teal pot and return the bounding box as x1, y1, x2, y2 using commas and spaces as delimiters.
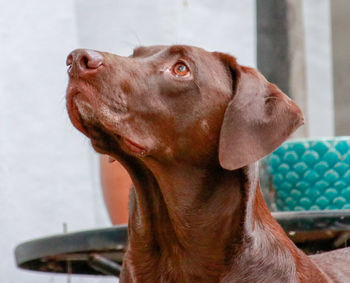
303, 0, 335, 137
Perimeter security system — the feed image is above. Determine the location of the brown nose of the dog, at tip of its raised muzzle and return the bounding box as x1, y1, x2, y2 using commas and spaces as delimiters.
66, 49, 103, 77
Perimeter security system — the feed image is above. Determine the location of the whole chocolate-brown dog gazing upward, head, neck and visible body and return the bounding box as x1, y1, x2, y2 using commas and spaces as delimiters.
67, 46, 350, 283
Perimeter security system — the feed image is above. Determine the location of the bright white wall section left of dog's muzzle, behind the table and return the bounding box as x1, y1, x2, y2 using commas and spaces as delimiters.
0, 0, 115, 283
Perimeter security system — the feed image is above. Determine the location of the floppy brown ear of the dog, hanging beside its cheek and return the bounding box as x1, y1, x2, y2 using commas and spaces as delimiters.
217, 53, 304, 170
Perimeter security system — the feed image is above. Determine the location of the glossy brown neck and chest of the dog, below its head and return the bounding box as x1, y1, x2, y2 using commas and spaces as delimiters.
122, 159, 326, 282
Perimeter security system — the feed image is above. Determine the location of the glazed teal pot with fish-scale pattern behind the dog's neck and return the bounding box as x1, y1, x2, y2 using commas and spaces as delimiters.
263, 137, 350, 211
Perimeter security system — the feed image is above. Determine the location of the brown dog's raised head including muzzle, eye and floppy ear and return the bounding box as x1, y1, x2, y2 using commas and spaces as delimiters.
67, 46, 303, 170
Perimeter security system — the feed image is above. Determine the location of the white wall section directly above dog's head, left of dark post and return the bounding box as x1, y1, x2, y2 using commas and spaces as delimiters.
76, 0, 256, 66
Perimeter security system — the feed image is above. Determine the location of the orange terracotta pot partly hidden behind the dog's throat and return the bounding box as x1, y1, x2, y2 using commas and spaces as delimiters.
100, 155, 132, 225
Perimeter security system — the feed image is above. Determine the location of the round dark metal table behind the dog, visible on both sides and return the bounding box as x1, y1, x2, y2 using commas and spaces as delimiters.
15, 210, 350, 277
